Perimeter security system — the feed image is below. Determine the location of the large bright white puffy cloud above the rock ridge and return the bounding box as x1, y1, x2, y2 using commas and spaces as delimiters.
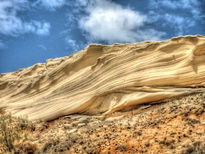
79, 0, 163, 43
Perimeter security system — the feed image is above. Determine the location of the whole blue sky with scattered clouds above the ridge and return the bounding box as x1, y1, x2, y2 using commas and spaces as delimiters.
0, 0, 205, 73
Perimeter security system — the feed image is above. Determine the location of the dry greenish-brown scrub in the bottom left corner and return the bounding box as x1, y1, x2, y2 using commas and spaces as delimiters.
0, 114, 36, 153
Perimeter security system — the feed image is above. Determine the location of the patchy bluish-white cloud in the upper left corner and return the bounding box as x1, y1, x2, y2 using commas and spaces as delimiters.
0, 0, 50, 35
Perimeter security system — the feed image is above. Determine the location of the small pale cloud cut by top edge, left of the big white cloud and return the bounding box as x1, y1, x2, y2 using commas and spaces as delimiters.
38, 0, 66, 10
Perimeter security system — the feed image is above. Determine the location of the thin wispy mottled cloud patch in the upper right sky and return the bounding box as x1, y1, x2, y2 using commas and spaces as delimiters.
149, 0, 201, 35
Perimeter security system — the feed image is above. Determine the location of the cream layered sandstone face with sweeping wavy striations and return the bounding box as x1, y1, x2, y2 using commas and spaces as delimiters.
0, 36, 205, 120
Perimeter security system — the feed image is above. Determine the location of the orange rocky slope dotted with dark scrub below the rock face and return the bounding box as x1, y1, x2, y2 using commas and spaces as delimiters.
0, 93, 205, 154
